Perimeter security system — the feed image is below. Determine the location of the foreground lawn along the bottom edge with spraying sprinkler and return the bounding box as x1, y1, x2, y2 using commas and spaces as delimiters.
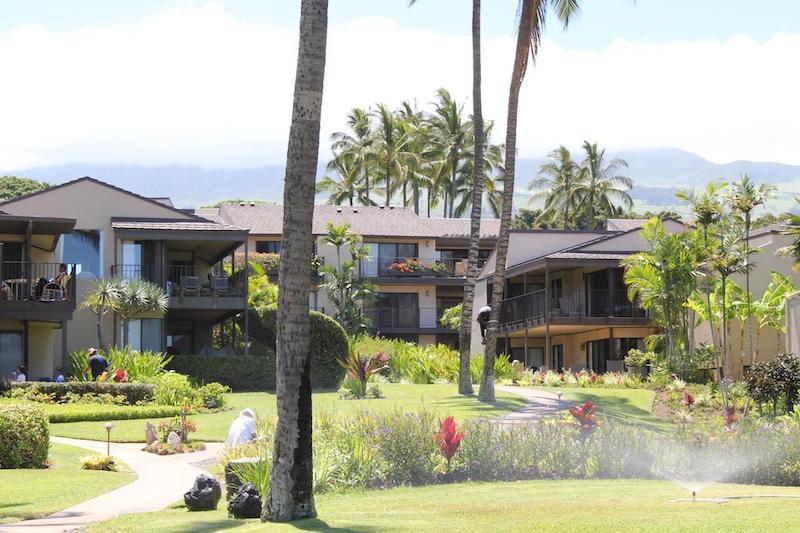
90, 480, 800, 533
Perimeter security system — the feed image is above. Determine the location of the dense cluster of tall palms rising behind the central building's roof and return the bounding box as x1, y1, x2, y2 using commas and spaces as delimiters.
317, 89, 503, 217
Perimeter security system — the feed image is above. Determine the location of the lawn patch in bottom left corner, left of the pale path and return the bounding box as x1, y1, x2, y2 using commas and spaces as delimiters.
0, 444, 136, 524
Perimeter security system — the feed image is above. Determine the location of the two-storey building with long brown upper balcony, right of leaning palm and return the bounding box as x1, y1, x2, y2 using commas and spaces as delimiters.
472, 219, 684, 372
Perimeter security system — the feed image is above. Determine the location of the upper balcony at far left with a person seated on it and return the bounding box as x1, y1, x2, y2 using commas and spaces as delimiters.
0, 261, 76, 321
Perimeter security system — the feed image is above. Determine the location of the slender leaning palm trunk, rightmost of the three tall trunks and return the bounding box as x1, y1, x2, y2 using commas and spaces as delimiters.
478, 2, 534, 402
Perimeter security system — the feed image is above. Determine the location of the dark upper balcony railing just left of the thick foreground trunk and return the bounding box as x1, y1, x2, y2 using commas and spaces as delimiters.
111, 264, 246, 298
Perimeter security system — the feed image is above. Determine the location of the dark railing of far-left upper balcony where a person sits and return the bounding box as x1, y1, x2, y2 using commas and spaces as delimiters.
0, 261, 76, 309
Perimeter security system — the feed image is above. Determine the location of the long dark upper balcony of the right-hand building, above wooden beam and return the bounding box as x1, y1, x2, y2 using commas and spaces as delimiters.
500, 289, 649, 330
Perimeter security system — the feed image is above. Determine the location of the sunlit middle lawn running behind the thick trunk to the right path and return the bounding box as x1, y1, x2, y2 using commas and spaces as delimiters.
50, 383, 525, 442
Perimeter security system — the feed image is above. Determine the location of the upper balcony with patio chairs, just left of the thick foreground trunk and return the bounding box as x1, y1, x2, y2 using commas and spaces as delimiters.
111, 264, 247, 309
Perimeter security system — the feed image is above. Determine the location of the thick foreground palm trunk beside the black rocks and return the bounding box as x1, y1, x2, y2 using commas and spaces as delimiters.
261, 0, 328, 522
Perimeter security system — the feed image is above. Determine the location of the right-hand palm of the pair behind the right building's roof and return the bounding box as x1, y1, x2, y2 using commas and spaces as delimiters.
574, 141, 633, 230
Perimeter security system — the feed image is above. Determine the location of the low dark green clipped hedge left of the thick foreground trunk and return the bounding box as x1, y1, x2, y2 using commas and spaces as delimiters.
168, 349, 276, 392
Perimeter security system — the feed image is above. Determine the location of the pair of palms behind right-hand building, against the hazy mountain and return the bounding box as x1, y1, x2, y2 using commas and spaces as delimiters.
528, 141, 633, 229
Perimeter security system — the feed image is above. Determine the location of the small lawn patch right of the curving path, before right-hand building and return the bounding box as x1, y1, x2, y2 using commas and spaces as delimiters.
539, 387, 671, 429
